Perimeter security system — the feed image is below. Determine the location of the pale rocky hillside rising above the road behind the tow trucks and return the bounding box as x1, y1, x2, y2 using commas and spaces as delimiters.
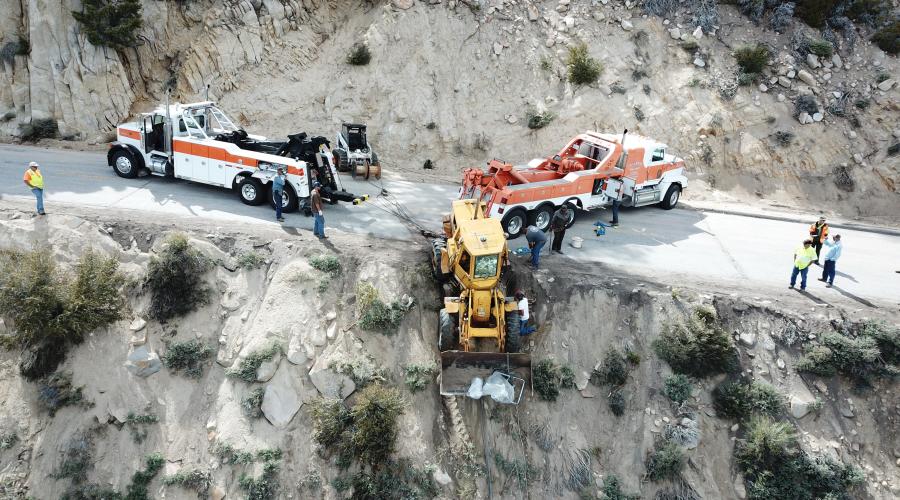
0, 0, 900, 221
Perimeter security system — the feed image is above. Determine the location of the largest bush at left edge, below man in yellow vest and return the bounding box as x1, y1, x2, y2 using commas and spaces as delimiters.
0, 249, 125, 379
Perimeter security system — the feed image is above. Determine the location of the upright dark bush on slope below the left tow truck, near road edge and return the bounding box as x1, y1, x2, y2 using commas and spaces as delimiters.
145, 234, 212, 322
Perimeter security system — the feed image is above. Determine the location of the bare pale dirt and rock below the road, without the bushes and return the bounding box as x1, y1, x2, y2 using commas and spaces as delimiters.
0, 211, 900, 498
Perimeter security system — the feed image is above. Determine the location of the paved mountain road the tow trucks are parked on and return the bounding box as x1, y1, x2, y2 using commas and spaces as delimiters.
0, 145, 900, 308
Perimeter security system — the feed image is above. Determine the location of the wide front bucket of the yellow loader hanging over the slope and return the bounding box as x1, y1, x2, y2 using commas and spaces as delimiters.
441, 351, 531, 404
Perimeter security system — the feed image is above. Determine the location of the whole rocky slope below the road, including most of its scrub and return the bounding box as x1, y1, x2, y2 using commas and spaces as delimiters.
0, 209, 900, 500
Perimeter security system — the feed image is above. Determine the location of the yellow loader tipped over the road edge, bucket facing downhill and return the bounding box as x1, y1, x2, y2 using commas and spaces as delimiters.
432, 200, 531, 403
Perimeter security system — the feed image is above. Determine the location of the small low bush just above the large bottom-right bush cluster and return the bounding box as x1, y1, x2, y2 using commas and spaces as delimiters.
713, 380, 785, 420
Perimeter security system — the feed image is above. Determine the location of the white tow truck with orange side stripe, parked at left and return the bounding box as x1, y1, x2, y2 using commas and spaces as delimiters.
107, 101, 357, 212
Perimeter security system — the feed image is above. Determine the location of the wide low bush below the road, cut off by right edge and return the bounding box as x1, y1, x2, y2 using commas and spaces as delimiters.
797, 329, 900, 385
